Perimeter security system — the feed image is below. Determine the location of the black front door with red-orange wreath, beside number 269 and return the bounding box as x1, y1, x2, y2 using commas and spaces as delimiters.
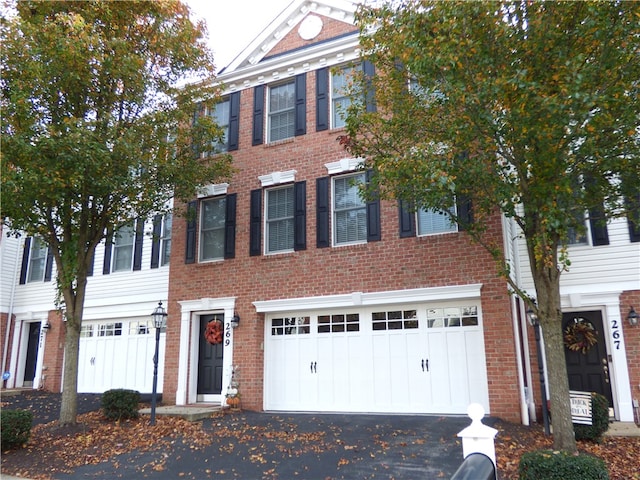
198, 313, 224, 395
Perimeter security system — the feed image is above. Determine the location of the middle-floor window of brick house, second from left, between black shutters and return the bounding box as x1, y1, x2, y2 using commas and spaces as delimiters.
265, 185, 294, 253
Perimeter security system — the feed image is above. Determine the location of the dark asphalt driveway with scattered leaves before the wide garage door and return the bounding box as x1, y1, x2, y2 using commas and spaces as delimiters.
2, 394, 492, 480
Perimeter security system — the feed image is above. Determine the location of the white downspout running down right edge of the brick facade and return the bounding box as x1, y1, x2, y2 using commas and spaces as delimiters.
502, 215, 531, 425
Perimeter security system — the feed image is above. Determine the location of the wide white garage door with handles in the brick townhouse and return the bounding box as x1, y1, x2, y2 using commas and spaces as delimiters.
264, 304, 489, 414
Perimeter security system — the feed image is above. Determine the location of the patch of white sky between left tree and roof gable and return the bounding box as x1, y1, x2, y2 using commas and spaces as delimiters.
183, 0, 292, 70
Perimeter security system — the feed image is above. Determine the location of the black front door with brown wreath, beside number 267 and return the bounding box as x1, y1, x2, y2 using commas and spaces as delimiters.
562, 311, 613, 408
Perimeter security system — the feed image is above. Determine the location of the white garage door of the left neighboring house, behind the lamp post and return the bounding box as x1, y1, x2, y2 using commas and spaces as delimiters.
78, 319, 165, 393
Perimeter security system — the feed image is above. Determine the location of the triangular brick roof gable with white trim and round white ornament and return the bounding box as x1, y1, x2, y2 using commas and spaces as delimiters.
220, 0, 357, 74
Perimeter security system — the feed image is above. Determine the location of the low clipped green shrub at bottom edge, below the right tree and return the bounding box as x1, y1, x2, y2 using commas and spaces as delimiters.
518, 450, 609, 480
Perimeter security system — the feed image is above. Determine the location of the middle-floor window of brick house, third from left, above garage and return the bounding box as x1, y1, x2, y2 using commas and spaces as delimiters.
333, 173, 367, 245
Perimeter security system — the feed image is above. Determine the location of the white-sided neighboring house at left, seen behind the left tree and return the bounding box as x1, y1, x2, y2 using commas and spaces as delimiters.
0, 215, 171, 393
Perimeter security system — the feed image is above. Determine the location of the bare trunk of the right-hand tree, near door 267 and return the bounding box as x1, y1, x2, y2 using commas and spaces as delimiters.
533, 266, 577, 453
